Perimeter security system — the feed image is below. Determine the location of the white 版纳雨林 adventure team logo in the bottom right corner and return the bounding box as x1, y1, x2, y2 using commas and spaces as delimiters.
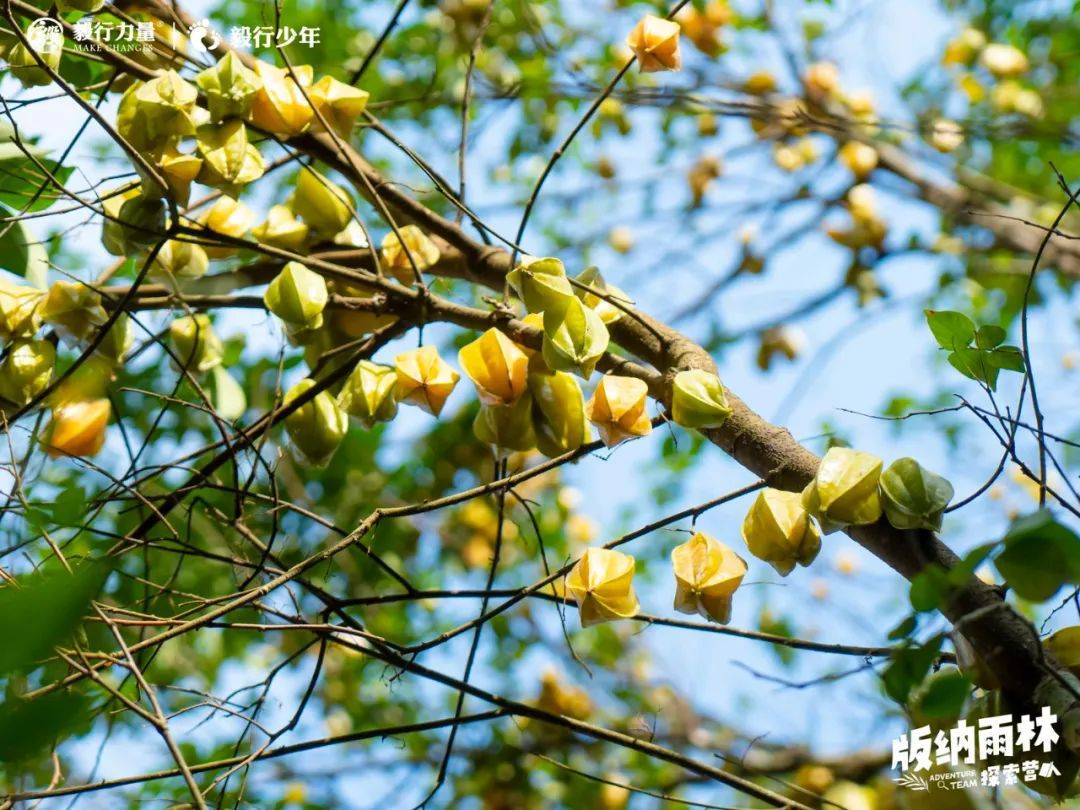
892, 706, 1061, 791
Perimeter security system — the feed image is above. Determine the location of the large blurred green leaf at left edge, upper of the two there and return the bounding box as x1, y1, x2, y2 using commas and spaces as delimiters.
0, 563, 107, 675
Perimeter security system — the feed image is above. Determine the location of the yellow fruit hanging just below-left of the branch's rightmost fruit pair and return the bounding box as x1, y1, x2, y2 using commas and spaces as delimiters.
742, 488, 821, 577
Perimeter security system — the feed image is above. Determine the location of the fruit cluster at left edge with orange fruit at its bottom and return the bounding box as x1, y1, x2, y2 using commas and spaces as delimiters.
0, 280, 139, 457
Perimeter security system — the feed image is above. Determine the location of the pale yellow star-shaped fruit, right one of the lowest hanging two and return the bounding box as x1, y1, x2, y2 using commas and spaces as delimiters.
672, 531, 746, 624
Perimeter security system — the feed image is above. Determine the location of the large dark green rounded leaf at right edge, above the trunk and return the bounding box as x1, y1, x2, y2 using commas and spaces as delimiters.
994, 510, 1080, 602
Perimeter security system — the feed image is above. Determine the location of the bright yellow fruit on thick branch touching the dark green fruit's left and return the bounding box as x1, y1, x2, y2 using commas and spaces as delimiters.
802, 447, 881, 535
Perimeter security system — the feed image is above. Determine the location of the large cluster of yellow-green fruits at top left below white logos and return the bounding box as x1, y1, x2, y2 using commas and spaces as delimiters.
103, 53, 368, 279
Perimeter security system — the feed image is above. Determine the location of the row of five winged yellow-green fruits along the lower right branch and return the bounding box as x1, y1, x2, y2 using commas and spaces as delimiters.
566, 447, 953, 626
